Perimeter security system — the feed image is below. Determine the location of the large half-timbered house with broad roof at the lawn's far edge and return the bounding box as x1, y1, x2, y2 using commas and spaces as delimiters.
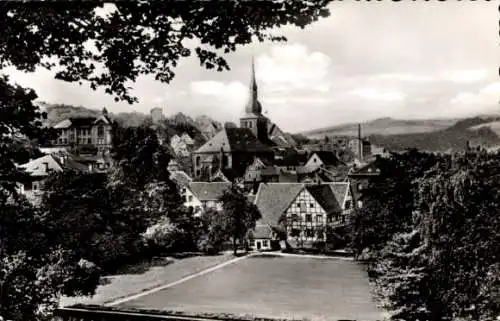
255, 182, 354, 247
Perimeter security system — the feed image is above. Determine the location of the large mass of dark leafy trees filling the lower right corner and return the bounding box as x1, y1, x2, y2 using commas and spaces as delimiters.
355, 151, 500, 320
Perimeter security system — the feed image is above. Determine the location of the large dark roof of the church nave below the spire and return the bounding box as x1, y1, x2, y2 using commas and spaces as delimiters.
196, 128, 272, 153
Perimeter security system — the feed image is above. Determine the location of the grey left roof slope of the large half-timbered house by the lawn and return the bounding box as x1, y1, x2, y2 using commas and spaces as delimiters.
255, 183, 304, 226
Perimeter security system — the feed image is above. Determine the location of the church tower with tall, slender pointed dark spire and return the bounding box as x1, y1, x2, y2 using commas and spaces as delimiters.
240, 57, 268, 142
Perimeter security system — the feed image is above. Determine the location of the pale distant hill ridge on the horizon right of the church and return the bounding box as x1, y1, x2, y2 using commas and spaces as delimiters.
302, 117, 457, 138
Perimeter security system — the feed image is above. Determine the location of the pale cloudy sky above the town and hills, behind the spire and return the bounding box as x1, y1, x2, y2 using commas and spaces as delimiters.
4, 1, 500, 132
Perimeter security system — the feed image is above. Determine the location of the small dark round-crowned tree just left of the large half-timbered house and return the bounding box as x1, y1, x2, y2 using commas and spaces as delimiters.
219, 184, 262, 255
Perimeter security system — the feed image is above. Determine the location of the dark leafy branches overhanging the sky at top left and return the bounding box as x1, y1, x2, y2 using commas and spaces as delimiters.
0, 0, 331, 103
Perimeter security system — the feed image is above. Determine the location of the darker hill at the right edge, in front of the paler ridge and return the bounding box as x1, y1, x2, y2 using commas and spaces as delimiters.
369, 116, 500, 152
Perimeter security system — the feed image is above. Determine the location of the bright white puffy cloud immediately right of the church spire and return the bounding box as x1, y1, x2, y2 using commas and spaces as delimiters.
256, 43, 331, 92
